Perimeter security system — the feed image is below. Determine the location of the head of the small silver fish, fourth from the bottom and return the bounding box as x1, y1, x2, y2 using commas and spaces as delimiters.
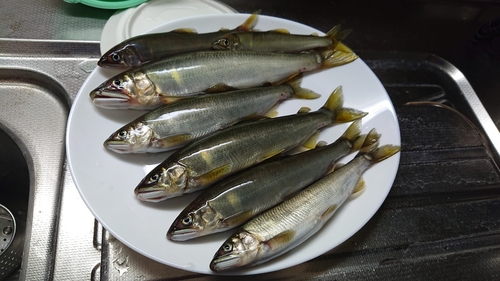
104, 122, 154, 154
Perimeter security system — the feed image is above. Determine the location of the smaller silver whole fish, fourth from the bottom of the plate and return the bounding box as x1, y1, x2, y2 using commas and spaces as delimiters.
104, 80, 319, 154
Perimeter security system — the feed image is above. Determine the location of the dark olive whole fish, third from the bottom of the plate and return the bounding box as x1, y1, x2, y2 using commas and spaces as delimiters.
135, 88, 366, 202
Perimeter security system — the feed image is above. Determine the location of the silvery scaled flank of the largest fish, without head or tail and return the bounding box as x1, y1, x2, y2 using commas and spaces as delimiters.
143, 51, 322, 97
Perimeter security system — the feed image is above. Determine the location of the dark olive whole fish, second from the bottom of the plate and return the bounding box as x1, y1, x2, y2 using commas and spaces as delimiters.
167, 121, 368, 241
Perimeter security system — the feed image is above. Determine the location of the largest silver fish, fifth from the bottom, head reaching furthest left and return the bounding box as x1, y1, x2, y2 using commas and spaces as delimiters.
90, 46, 357, 109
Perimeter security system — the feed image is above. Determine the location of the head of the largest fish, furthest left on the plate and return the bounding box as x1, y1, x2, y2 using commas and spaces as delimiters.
90, 71, 159, 109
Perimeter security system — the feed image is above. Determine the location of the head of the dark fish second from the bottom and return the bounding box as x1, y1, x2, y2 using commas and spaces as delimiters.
167, 201, 221, 241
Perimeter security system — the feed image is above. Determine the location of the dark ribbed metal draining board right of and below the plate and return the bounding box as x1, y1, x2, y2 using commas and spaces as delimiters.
77, 52, 500, 280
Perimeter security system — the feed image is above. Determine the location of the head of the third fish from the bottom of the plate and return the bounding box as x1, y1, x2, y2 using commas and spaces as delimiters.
134, 163, 189, 202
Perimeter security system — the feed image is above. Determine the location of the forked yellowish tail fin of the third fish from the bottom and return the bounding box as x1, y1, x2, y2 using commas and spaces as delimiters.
322, 86, 368, 124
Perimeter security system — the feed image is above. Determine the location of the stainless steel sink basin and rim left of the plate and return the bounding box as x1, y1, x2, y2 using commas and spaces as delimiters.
0, 40, 100, 280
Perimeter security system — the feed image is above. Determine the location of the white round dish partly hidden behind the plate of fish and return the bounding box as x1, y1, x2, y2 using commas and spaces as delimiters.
100, 0, 235, 54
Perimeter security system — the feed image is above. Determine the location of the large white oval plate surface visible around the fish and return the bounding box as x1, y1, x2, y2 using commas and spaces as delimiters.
66, 14, 400, 274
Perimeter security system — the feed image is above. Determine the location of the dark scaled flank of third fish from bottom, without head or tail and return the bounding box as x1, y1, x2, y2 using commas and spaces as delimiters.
176, 113, 331, 182
